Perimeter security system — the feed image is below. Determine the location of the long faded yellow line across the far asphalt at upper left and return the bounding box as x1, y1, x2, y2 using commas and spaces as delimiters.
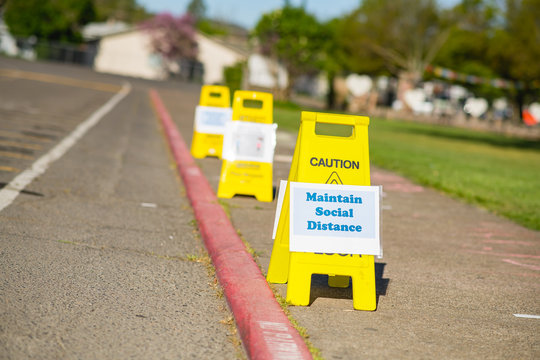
0, 69, 121, 93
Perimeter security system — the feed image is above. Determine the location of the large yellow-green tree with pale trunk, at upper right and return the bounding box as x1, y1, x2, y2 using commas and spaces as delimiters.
341, 0, 451, 104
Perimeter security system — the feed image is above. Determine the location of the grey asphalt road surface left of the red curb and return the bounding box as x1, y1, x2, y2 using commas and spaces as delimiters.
0, 59, 240, 359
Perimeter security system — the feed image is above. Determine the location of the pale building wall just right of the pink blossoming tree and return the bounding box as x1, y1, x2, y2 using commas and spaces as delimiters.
196, 34, 245, 84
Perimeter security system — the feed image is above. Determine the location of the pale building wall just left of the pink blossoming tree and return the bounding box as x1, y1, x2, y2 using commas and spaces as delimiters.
94, 31, 168, 80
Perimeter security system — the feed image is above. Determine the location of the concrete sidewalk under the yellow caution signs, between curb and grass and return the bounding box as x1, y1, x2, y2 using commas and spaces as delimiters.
159, 90, 540, 359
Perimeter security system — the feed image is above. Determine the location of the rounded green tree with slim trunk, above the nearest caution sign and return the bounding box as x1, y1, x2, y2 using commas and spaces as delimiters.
253, 4, 324, 99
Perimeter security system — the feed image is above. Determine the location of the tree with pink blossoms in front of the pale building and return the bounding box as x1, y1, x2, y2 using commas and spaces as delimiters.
141, 13, 198, 61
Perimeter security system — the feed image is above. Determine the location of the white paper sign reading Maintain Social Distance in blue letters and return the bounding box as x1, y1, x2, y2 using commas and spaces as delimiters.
289, 182, 382, 257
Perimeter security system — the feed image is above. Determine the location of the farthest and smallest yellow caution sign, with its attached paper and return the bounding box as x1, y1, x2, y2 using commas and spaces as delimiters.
191, 85, 232, 159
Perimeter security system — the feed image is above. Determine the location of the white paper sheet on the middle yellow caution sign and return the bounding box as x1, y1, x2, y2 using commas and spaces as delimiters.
222, 121, 277, 163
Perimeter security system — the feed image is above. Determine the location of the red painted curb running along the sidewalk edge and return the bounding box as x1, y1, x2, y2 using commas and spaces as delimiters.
150, 89, 312, 359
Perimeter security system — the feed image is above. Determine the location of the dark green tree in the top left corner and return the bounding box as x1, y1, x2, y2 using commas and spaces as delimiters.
4, 0, 96, 42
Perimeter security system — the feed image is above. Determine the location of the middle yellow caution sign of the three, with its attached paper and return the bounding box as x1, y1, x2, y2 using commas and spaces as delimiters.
217, 91, 276, 202
